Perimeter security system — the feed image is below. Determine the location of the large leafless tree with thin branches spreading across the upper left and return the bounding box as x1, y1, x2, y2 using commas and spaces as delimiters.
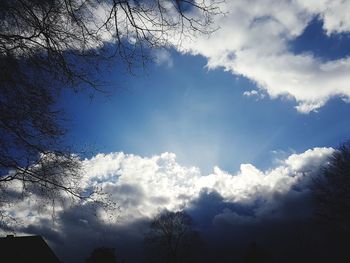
0, 0, 219, 225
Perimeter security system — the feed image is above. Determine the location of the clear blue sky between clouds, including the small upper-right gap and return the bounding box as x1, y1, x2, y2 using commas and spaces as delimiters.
58, 31, 350, 173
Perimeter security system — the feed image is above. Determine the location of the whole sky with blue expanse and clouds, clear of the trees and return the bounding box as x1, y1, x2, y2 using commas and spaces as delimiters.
3, 0, 350, 262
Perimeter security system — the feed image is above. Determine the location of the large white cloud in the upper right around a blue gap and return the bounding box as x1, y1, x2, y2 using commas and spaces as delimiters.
176, 0, 350, 113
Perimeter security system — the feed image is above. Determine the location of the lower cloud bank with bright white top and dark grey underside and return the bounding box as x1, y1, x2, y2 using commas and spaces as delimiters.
0, 148, 334, 262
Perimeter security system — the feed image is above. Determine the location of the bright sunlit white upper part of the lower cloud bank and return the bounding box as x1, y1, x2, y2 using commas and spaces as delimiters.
2, 148, 334, 234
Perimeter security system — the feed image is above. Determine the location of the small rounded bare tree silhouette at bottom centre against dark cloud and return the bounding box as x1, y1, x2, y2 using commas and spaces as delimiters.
145, 211, 200, 263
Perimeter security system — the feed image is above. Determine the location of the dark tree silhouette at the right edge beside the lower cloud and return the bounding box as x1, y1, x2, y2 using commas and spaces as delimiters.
312, 142, 350, 262
